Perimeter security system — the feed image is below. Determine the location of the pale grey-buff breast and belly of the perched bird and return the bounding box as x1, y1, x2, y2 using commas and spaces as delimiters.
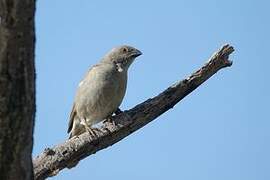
76, 65, 127, 125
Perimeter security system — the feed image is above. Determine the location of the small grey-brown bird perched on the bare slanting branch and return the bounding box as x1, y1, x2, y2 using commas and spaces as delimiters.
68, 45, 142, 138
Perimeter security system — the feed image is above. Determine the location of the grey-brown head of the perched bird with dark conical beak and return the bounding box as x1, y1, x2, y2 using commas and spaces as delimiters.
102, 45, 142, 72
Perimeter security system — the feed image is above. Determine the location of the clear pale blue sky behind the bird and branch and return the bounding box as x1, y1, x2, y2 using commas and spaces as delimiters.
33, 0, 270, 180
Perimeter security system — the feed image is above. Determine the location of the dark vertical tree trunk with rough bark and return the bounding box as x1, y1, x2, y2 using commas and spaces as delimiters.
0, 0, 35, 180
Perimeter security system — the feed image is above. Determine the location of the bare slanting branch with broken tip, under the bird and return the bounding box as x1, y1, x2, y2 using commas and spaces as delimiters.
33, 45, 234, 179
